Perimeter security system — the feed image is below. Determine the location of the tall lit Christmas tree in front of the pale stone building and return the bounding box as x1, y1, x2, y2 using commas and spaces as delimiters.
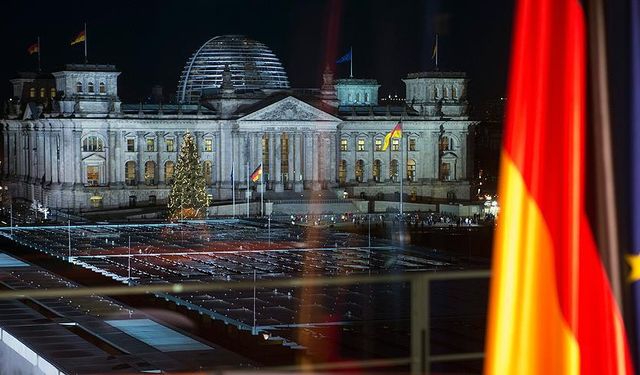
167, 132, 207, 220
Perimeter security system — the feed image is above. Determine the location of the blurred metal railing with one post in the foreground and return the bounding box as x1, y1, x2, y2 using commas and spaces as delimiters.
0, 270, 490, 374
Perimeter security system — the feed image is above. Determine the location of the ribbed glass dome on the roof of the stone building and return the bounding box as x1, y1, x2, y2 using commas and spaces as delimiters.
177, 35, 289, 103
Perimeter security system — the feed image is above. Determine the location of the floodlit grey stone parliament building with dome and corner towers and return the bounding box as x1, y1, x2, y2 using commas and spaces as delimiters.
0, 35, 475, 209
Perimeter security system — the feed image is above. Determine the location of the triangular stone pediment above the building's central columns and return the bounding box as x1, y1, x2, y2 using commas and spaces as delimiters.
239, 96, 340, 122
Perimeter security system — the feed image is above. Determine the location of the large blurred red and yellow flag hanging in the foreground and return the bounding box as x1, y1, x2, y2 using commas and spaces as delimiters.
485, 0, 633, 375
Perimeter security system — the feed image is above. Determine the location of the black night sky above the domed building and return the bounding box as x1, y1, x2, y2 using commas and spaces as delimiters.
0, 0, 513, 106
